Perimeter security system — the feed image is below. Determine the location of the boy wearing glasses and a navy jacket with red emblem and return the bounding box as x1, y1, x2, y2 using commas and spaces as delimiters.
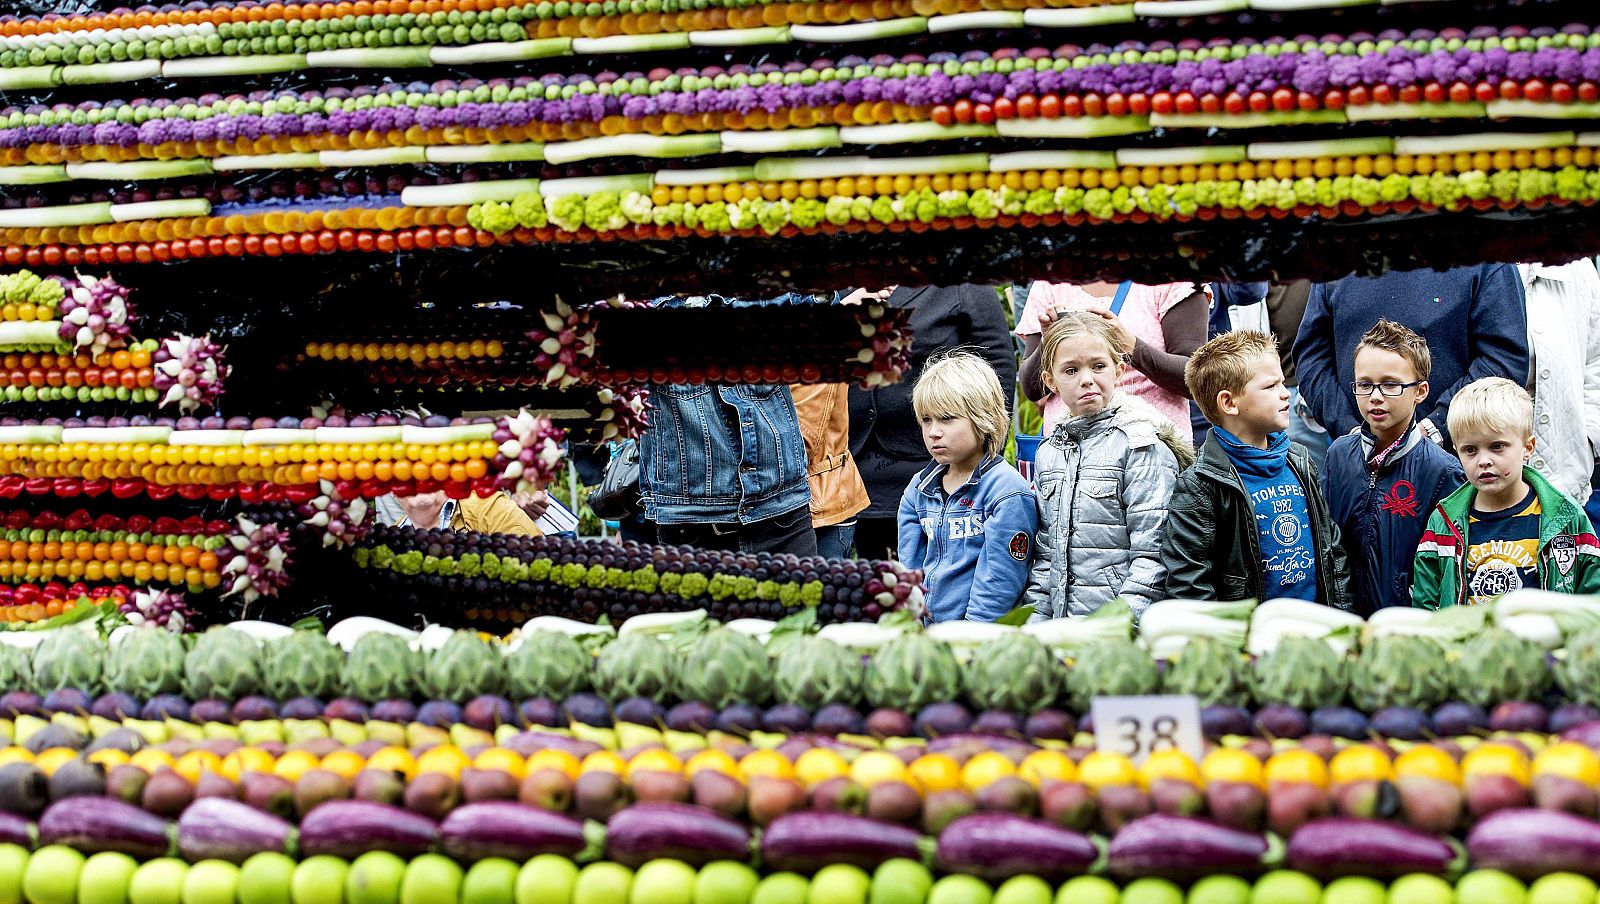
1323, 320, 1466, 616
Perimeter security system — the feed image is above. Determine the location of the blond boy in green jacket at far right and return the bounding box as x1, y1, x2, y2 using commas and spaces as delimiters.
1411, 376, 1600, 610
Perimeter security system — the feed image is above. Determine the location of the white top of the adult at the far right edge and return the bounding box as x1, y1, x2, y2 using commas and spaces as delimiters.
1517, 258, 1600, 506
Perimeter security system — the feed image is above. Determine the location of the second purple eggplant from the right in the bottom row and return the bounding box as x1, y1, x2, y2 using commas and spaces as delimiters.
1286, 816, 1464, 882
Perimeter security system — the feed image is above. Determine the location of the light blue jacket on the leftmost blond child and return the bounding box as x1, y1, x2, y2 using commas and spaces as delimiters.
899, 456, 1038, 621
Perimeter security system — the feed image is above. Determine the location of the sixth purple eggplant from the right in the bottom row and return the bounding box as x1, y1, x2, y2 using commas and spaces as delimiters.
605, 802, 752, 867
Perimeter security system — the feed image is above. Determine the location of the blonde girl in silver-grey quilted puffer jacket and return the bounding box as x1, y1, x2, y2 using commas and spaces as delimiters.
1024, 312, 1194, 621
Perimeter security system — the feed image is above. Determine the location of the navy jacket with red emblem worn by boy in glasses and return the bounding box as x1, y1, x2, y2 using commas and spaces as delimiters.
1322, 422, 1467, 616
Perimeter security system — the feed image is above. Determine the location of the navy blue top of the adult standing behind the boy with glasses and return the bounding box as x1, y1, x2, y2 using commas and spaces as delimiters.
1294, 264, 1528, 437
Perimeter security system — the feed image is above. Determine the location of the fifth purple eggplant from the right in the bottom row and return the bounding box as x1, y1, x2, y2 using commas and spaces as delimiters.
762, 811, 928, 872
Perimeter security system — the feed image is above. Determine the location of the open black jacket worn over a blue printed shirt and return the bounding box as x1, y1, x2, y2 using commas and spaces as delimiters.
1162, 435, 1352, 611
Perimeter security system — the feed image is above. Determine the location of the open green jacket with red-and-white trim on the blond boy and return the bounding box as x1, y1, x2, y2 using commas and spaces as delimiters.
1411, 466, 1600, 610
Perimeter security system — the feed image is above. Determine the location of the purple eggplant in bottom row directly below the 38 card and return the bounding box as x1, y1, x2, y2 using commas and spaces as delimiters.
1107, 813, 1282, 882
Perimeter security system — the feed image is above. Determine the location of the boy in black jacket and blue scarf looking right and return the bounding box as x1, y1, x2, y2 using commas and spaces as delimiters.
1162, 330, 1350, 610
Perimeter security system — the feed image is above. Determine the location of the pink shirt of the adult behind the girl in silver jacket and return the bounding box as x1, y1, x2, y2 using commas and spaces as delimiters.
1016, 282, 1195, 440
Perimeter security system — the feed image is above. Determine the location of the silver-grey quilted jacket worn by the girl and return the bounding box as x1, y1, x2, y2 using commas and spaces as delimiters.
1024, 395, 1194, 621
